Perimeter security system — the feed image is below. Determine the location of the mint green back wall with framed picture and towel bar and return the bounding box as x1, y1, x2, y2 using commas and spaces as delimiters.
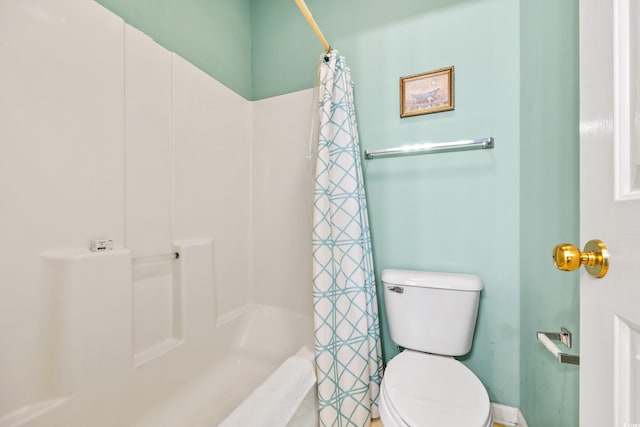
252, 0, 520, 406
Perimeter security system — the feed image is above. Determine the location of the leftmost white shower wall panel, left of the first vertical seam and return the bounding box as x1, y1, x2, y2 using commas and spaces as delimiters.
0, 0, 125, 414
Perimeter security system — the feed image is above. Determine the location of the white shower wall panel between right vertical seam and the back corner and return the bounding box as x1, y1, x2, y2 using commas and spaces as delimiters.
173, 45, 251, 316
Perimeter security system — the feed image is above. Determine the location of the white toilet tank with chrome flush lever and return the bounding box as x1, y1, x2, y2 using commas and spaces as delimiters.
382, 269, 483, 356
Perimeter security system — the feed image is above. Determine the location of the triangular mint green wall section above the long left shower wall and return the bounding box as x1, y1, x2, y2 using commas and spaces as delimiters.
96, 0, 253, 99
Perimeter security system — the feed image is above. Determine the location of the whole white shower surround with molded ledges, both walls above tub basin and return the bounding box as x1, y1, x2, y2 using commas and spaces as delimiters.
0, 0, 312, 427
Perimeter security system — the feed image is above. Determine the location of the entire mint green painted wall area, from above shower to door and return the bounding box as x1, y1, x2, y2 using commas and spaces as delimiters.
90, 0, 579, 427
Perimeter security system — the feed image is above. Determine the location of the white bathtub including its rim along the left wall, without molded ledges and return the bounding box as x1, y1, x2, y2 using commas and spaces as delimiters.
0, 306, 318, 427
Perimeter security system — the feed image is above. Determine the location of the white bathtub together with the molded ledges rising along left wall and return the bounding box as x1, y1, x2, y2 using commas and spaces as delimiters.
0, 246, 317, 427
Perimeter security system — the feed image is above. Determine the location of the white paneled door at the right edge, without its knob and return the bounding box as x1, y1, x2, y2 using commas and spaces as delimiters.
580, 0, 640, 427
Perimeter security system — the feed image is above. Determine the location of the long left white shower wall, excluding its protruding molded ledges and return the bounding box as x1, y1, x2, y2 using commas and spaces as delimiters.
0, 0, 251, 420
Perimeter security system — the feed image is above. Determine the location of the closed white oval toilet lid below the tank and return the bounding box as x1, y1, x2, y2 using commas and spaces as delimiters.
382, 350, 491, 427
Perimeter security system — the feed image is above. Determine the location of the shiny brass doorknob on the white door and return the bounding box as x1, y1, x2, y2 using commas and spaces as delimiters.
553, 239, 609, 279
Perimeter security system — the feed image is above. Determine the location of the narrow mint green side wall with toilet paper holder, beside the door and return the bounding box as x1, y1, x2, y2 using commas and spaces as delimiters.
520, 0, 580, 427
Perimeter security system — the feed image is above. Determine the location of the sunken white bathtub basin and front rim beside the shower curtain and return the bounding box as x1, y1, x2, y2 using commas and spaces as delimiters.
133, 306, 318, 427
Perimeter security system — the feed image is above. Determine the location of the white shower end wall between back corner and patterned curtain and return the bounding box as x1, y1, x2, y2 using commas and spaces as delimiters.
251, 89, 317, 313
